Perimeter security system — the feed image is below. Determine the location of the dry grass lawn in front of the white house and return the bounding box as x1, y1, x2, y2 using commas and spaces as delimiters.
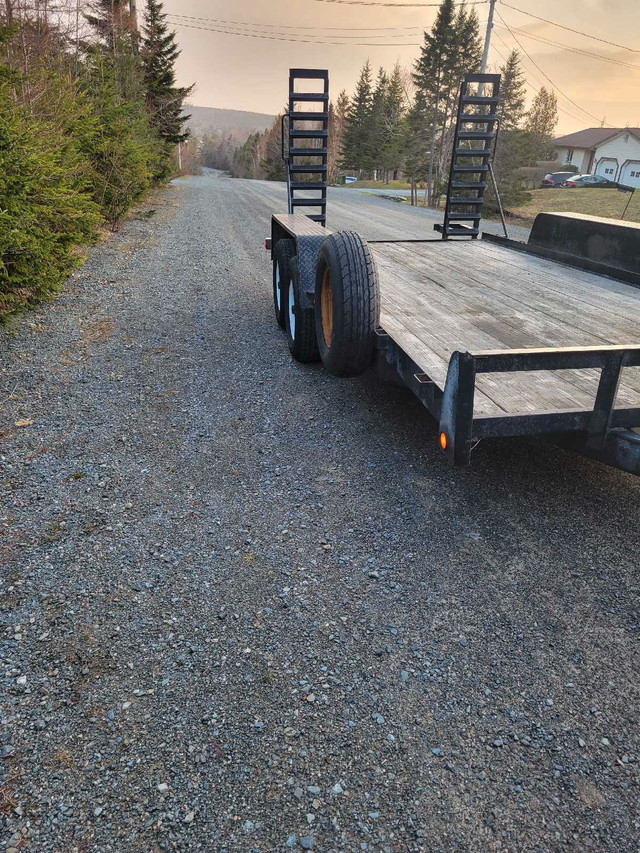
507, 189, 640, 222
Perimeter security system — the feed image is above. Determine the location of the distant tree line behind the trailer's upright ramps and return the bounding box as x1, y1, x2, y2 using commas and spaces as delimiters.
231, 0, 558, 204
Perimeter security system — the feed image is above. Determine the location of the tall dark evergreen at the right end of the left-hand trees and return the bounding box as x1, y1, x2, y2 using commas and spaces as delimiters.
140, 0, 193, 145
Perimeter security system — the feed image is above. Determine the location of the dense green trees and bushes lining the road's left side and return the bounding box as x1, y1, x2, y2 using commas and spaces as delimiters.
0, 0, 190, 319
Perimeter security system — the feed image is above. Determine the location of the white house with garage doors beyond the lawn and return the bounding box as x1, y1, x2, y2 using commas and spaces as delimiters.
554, 127, 640, 187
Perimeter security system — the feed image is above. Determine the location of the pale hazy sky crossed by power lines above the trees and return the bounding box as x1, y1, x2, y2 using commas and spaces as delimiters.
164, 0, 640, 133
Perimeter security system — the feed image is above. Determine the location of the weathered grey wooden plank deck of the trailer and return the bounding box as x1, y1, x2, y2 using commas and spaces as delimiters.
369, 240, 640, 415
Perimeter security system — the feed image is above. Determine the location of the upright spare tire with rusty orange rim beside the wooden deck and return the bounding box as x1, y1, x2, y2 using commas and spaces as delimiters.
315, 231, 380, 376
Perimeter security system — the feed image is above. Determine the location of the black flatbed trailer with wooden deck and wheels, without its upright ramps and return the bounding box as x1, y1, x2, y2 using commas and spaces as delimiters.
268, 70, 640, 473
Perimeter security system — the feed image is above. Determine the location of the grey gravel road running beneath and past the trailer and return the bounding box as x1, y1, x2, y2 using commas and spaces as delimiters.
0, 168, 640, 853
